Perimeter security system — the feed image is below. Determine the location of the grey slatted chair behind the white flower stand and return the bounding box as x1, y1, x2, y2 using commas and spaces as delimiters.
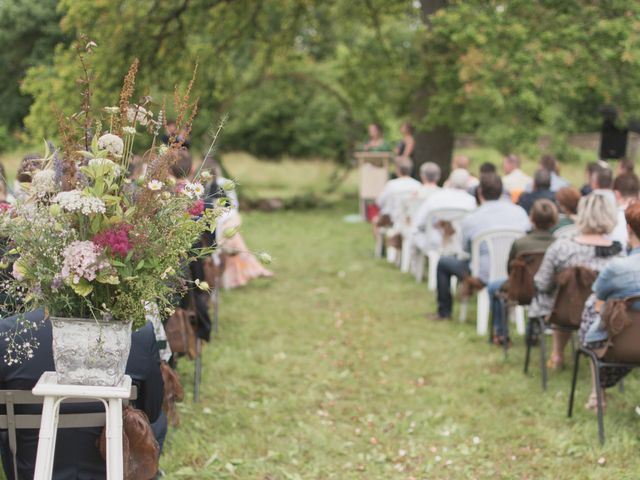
0, 385, 138, 479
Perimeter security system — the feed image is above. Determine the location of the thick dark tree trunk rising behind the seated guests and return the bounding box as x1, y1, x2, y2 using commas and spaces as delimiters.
413, 0, 455, 181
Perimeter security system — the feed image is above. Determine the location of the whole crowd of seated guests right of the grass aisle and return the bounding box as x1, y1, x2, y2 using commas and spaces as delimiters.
372, 147, 640, 416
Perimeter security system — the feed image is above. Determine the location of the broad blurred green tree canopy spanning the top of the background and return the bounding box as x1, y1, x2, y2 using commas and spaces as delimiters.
11, 0, 640, 169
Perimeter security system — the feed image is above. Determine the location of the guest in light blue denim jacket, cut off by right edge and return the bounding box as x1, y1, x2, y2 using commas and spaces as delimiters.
580, 202, 640, 409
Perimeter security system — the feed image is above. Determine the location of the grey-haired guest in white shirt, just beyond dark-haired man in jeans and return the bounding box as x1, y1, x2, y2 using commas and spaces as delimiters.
412, 169, 476, 255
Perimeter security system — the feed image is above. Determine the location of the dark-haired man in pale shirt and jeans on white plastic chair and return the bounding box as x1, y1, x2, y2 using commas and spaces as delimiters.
434, 174, 530, 319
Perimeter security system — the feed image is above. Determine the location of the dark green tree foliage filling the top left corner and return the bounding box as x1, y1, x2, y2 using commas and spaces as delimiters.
0, 0, 65, 129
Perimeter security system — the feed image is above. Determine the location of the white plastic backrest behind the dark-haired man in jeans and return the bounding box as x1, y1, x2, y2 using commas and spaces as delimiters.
471, 228, 525, 282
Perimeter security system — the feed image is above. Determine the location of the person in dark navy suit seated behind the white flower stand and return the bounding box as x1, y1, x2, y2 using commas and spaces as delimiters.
0, 310, 163, 480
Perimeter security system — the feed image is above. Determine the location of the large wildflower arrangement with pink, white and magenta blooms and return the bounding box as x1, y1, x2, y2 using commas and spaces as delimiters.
0, 47, 225, 363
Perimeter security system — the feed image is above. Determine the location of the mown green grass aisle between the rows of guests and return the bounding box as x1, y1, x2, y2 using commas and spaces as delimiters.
162, 201, 640, 480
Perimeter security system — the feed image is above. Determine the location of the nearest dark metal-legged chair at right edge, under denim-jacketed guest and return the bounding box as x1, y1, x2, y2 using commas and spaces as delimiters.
567, 296, 640, 445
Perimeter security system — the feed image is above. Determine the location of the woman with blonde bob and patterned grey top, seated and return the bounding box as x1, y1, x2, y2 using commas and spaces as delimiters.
529, 193, 623, 368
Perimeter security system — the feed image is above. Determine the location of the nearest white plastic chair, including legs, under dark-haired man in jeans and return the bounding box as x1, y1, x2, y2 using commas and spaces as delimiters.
460, 228, 525, 335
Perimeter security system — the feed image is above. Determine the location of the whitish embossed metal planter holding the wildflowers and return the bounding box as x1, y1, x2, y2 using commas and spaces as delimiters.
49, 317, 131, 386
